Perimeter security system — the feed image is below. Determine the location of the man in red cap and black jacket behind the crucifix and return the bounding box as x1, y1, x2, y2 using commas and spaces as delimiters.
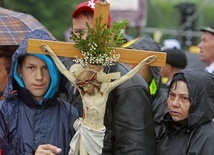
72, 0, 156, 155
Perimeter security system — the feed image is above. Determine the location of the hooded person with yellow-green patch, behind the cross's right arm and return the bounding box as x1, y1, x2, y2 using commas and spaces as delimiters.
123, 36, 167, 140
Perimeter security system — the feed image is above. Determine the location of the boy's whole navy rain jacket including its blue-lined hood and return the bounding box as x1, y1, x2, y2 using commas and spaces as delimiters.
0, 30, 79, 155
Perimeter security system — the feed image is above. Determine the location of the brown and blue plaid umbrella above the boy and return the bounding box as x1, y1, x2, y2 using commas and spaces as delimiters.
0, 7, 55, 46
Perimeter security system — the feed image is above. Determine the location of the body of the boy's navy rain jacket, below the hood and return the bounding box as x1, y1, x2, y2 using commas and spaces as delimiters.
0, 91, 78, 155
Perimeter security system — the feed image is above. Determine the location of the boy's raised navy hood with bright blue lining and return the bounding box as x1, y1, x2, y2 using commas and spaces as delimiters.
4, 30, 61, 104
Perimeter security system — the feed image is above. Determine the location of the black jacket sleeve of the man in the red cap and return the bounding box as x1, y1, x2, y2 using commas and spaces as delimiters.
103, 85, 156, 155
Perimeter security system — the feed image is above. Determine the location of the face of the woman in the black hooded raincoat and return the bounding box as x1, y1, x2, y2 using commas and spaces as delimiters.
167, 81, 190, 121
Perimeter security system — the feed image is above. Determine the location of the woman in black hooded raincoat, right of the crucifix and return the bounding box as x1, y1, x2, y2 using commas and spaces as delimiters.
157, 69, 214, 155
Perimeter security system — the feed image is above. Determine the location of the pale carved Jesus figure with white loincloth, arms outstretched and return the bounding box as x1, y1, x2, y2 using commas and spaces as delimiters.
41, 44, 156, 155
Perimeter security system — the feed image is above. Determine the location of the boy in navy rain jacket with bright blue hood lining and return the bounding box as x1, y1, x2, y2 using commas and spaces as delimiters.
0, 30, 79, 155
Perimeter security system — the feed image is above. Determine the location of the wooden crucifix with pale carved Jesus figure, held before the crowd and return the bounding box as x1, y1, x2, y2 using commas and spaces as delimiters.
28, 2, 166, 155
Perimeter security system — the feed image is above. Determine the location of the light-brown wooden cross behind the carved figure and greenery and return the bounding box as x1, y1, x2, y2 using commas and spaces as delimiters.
27, 2, 166, 67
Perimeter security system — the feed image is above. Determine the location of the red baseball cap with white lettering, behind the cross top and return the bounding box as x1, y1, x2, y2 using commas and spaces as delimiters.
72, 0, 111, 27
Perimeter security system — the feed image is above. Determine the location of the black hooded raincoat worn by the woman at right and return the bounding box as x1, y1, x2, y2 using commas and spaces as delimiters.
157, 69, 214, 155
